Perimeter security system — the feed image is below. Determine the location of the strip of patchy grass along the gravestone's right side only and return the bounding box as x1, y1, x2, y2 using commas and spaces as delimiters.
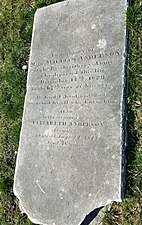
103, 1, 142, 225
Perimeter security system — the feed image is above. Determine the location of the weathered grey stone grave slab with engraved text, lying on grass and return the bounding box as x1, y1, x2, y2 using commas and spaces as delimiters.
14, 0, 127, 225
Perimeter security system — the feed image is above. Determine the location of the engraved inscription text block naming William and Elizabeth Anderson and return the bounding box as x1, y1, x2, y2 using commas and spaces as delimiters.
27, 47, 120, 147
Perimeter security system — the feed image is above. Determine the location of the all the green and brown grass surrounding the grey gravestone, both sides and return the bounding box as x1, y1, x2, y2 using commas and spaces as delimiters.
0, 0, 142, 225
